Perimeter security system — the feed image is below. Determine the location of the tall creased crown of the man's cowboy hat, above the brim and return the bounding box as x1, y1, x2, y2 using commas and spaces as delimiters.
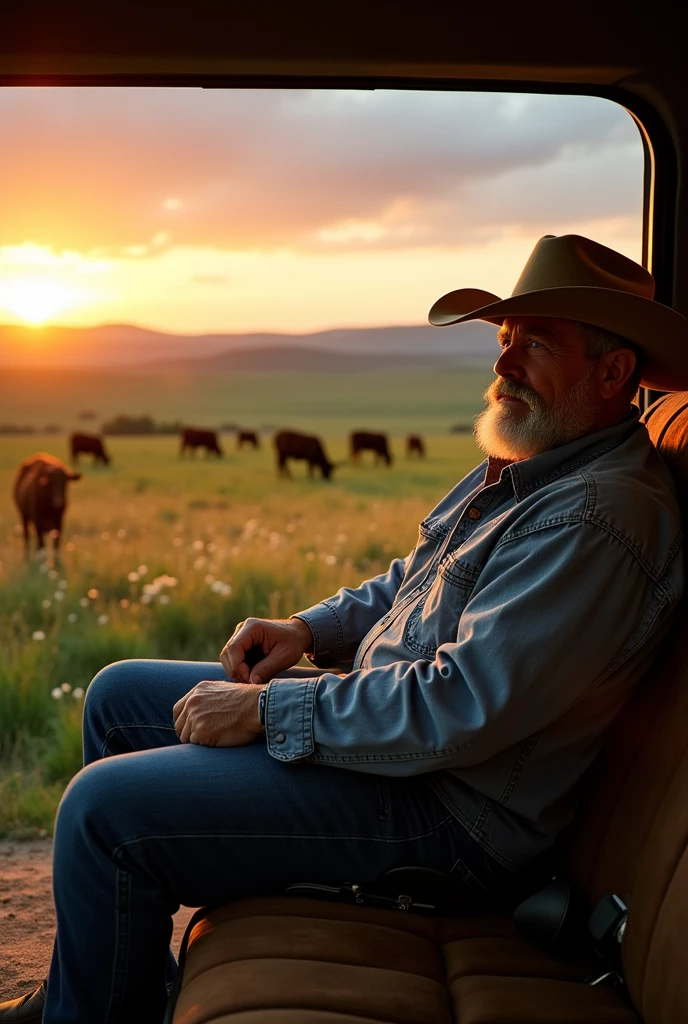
511, 234, 654, 299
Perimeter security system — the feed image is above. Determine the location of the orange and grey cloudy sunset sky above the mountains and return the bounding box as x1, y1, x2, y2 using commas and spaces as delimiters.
0, 88, 643, 333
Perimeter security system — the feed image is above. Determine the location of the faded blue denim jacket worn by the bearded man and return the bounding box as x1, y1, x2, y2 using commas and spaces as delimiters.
266, 412, 684, 869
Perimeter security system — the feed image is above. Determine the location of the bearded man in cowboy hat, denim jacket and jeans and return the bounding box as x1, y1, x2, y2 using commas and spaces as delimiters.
0, 236, 688, 1024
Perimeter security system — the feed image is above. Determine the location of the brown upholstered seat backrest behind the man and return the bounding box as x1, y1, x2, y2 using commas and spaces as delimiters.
563, 393, 688, 1024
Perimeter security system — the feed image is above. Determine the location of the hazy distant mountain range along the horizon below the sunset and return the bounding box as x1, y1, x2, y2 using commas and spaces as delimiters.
0, 322, 497, 373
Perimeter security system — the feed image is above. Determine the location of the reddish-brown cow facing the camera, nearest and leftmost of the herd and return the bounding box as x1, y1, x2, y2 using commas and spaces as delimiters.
14, 452, 81, 555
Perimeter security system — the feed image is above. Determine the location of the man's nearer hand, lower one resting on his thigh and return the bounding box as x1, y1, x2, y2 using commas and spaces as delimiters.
172, 680, 264, 746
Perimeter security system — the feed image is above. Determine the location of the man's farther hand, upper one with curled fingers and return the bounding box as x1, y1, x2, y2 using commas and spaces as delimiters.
220, 618, 313, 685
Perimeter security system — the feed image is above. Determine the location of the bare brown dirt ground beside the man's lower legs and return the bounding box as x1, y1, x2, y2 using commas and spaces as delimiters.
0, 840, 194, 1002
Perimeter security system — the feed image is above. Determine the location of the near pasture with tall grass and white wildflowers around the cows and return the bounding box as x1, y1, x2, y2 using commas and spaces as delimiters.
0, 389, 487, 837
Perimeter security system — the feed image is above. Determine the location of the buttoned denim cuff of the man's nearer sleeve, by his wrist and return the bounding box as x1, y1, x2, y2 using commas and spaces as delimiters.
265, 679, 318, 761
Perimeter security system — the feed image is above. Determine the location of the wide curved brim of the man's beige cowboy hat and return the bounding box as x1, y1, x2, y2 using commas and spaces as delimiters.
428, 285, 688, 391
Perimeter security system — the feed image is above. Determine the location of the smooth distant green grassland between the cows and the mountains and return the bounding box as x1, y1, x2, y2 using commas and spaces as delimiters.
0, 367, 492, 436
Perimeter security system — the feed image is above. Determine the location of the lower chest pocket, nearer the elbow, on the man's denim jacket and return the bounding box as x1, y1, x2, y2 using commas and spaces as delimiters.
403, 556, 480, 659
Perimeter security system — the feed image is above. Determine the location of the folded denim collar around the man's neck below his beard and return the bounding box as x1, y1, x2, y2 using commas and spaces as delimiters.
502, 406, 640, 502
